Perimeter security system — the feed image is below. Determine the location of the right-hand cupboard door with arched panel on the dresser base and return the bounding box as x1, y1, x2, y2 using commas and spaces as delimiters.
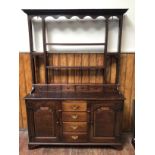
90, 103, 122, 142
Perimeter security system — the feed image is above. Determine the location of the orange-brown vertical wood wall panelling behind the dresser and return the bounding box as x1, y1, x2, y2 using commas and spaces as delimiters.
19, 52, 135, 131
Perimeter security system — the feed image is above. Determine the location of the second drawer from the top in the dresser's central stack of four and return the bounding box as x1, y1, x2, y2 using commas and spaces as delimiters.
62, 112, 87, 122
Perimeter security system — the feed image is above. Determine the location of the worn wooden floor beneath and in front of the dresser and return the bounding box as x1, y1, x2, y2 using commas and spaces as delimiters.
19, 131, 134, 155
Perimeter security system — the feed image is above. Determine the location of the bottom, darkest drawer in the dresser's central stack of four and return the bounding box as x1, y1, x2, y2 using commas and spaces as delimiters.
63, 132, 87, 143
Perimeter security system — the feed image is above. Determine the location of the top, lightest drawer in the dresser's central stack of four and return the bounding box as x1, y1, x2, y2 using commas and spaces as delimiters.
62, 101, 87, 111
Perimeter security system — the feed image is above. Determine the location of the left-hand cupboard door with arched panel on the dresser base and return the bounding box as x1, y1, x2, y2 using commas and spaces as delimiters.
27, 101, 59, 142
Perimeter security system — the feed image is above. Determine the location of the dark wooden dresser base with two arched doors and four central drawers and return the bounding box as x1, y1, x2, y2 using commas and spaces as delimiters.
26, 99, 123, 149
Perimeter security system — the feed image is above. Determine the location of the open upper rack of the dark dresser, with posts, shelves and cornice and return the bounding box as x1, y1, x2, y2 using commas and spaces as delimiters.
23, 9, 128, 84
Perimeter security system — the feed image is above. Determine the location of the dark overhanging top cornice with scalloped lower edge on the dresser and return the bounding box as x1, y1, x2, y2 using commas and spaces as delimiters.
22, 8, 128, 18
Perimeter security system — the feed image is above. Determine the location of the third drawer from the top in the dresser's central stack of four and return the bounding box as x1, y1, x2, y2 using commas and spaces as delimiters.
63, 122, 87, 132
